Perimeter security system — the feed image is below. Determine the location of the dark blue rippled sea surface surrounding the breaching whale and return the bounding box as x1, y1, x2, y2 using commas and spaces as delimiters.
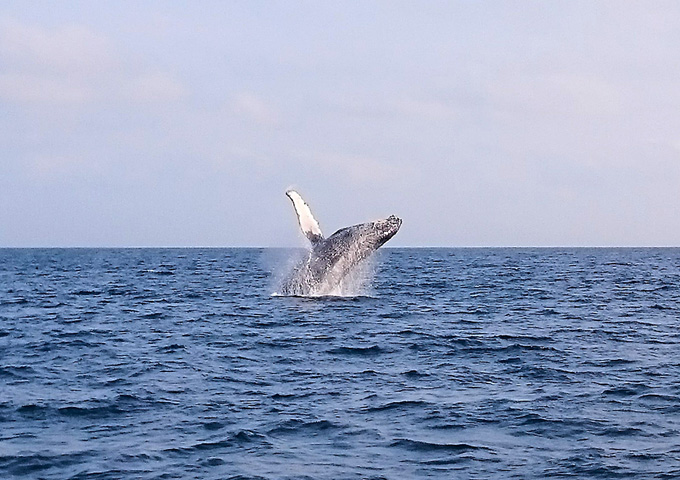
0, 249, 680, 480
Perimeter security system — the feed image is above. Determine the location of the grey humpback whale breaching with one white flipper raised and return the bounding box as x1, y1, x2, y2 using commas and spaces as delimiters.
281, 190, 401, 296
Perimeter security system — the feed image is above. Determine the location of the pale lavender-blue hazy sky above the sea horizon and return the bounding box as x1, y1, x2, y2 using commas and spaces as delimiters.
0, 0, 680, 247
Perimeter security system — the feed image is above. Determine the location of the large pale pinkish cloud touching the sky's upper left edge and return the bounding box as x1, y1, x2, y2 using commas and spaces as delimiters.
0, 17, 187, 107
